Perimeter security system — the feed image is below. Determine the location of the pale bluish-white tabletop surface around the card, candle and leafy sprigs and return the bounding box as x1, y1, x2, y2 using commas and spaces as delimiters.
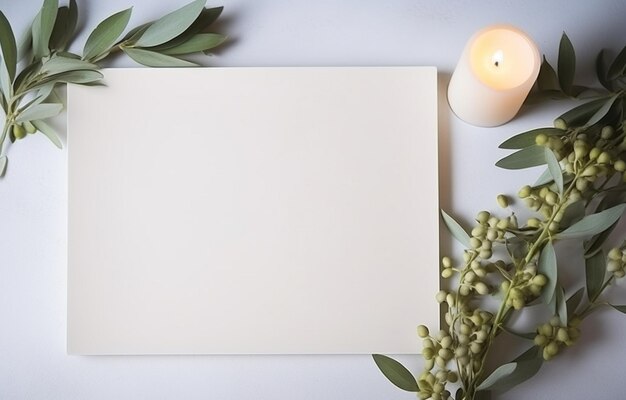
0, 0, 626, 400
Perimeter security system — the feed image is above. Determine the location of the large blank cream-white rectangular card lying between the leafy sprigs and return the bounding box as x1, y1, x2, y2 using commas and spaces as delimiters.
68, 67, 439, 354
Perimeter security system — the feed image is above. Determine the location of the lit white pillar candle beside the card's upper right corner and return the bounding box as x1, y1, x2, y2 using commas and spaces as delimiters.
448, 25, 540, 126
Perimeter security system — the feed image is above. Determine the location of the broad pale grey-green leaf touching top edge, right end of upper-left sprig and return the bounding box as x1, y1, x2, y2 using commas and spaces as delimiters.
136, 0, 206, 47
